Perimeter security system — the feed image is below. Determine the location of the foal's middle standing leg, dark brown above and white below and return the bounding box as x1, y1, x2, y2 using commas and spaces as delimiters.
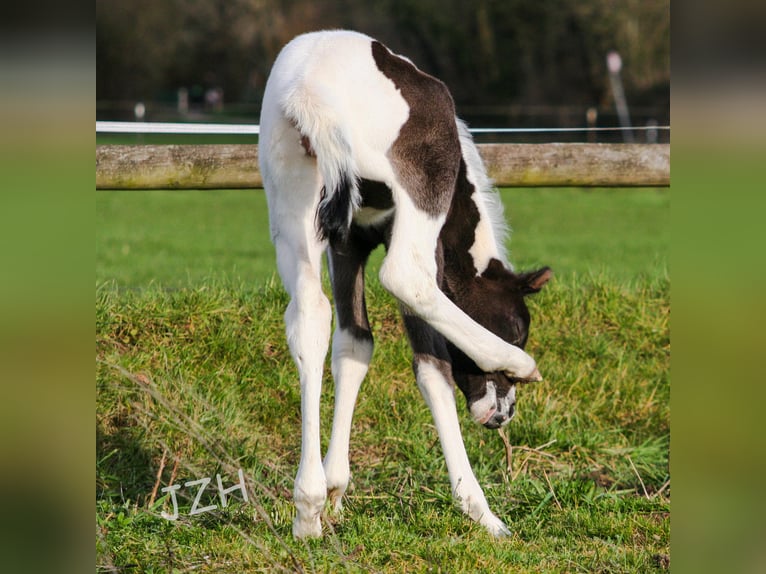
324, 238, 373, 512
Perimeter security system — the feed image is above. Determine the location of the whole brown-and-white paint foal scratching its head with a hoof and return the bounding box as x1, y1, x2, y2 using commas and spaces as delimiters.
259, 31, 551, 537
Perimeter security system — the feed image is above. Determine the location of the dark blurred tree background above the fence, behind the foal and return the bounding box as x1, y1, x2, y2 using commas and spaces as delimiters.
96, 0, 670, 142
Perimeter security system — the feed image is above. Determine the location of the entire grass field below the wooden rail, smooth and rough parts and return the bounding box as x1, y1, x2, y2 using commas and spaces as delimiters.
96, 189, 670, 572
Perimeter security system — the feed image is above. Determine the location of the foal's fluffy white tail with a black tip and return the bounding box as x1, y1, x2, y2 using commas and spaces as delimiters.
283, 86, 361, 243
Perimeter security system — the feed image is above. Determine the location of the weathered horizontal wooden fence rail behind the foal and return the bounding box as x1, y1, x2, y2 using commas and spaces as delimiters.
96, 143, 670, 189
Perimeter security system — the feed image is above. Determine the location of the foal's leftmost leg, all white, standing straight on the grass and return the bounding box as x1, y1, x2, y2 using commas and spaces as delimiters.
265, 122, 332, 538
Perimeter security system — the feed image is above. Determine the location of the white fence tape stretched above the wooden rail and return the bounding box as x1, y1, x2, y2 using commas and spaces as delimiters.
96, 122, 670, 135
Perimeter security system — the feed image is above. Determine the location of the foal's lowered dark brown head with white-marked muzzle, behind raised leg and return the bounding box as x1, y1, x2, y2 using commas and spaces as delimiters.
448, 259, 553, 429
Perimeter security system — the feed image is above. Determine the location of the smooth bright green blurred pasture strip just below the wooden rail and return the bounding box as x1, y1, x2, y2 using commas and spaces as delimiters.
96, 189, 670, 288
